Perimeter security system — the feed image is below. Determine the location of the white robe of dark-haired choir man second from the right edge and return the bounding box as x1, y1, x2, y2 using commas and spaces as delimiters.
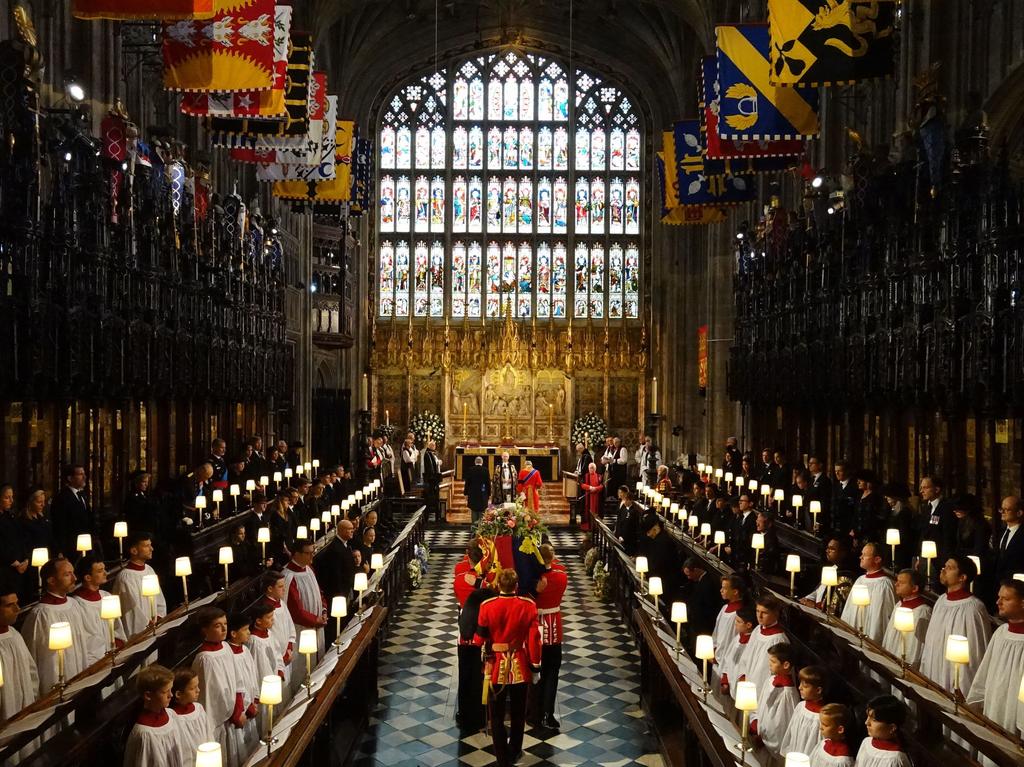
921, 591, 987, 691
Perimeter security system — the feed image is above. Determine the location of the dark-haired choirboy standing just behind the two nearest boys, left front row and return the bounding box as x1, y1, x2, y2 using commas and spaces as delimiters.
193, 607, 248, 767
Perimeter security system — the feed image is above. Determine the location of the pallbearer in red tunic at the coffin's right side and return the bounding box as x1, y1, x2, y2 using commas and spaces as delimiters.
529, 544, 568, 730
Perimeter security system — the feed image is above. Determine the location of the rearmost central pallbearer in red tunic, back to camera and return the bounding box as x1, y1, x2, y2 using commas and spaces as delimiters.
476, 569, 541, 767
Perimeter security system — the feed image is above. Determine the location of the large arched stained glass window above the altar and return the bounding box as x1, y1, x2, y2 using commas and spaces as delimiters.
376, 50, 646, 321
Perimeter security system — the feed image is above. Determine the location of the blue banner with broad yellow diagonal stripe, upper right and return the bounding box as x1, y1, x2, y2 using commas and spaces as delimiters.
715, 24, 818, 141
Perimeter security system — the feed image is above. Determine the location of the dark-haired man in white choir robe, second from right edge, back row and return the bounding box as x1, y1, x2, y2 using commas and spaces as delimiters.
921, 556, 991, 691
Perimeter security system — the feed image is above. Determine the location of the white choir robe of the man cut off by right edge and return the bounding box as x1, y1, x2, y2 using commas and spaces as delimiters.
967, 624, 1024, 735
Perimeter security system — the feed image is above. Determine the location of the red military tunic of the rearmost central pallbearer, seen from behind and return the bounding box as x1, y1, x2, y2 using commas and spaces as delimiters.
476, 594, 541, 685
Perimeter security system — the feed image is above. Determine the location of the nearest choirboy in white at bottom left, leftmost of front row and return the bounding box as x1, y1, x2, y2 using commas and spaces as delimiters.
124, 664, 193, 767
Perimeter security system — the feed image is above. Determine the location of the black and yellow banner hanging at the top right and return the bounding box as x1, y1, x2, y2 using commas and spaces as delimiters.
768, 0, 897, 86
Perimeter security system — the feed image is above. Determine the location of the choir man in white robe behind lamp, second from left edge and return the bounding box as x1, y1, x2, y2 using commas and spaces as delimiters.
22, 559, 89, 695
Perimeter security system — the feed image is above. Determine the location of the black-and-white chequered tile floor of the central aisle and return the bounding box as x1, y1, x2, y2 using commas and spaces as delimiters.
354, 528, 664, 767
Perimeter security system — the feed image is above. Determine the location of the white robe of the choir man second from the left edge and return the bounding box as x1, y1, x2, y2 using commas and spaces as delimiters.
22, 594, 89, 696
